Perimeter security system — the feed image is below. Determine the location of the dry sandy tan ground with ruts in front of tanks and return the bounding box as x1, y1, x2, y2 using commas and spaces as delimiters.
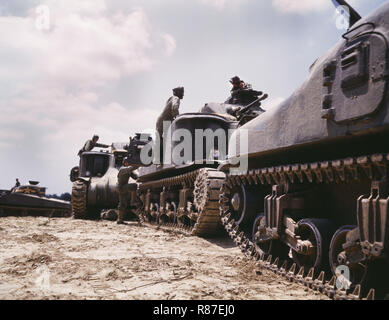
0, 217, 326, 300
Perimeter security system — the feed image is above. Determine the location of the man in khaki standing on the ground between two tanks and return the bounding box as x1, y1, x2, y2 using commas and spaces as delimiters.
116, 158, 138, 224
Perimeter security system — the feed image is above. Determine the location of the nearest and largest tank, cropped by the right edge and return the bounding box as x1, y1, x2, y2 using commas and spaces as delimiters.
220, 1, 389, 295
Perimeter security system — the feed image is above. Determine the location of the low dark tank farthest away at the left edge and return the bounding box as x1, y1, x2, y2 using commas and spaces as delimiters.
0, 181, 71, 217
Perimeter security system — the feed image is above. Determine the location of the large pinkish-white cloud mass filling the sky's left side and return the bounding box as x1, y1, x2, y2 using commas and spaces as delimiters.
0, 0, 176, 192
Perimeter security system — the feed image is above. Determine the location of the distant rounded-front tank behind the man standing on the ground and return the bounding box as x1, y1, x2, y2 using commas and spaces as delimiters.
70, 143, 136, 219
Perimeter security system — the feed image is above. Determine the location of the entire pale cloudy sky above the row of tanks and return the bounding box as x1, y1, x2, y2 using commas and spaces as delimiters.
0, 0, 385, 193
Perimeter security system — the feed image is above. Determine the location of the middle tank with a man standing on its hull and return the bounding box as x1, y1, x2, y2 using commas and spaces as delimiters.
129, 91, 267, 236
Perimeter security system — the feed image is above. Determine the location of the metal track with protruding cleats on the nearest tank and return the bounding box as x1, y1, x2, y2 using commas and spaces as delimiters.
220, 154, 389, 300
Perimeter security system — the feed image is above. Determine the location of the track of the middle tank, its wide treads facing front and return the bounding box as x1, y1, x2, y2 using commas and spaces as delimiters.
137, 168, 225, 237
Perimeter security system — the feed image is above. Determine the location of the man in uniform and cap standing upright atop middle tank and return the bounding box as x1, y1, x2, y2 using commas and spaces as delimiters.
156, 87, 184, 160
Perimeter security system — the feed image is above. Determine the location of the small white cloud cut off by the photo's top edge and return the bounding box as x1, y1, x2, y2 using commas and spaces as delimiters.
272, 0, 332, 14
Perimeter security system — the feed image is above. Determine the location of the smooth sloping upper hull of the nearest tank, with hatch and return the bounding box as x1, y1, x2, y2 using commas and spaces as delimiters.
229, 4, 389, 162
